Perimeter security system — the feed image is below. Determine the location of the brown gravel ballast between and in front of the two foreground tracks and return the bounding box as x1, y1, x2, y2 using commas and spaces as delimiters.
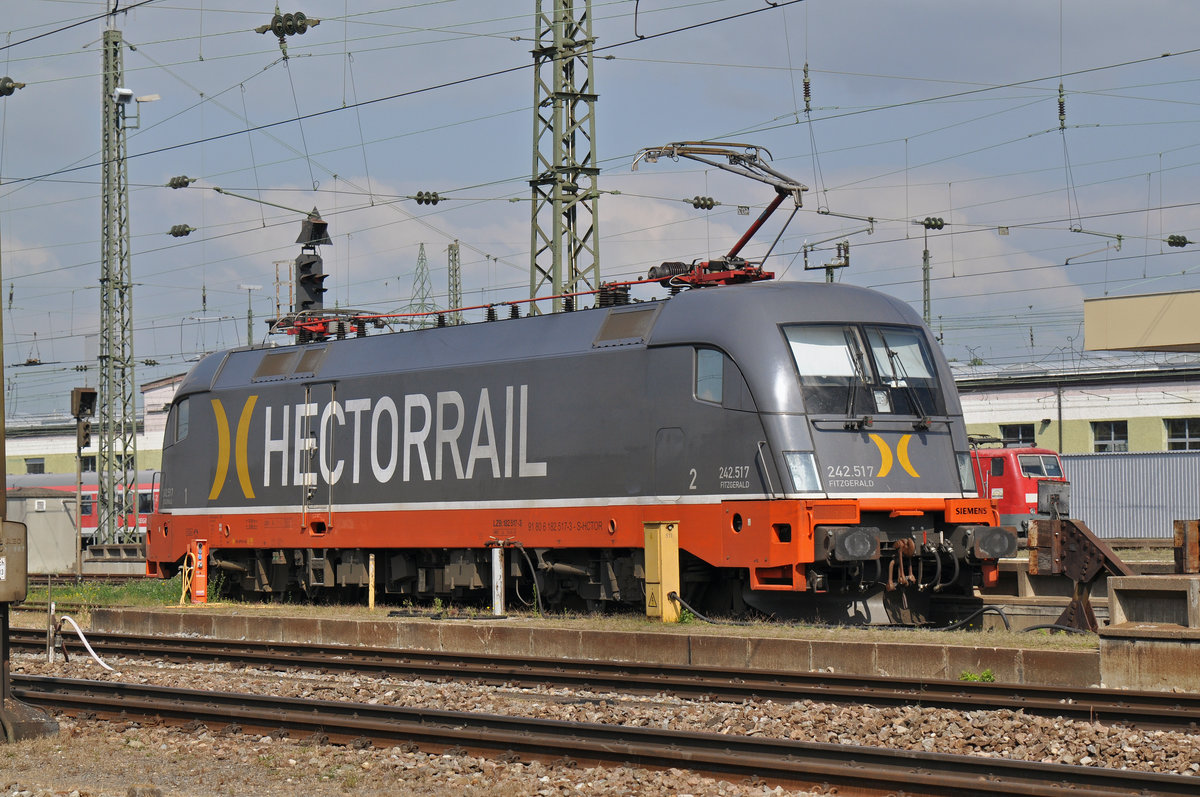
0, 654, 1200, 797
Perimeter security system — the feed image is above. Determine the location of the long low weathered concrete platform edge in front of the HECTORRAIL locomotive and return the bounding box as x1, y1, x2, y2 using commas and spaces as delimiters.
91, 609, 1100, 687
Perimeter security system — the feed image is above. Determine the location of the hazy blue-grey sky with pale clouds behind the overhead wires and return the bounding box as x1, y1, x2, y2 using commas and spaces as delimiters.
0, 0, 1200, 418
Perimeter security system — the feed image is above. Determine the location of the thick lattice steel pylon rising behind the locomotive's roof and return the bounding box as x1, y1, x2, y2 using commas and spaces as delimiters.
529, 0, 600, 313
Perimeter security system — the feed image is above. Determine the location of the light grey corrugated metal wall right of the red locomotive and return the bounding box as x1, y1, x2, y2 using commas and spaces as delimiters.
1062, 451, 1200, 538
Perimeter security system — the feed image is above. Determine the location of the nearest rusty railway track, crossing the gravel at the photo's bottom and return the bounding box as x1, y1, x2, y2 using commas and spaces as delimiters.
12, 676, 1196, 797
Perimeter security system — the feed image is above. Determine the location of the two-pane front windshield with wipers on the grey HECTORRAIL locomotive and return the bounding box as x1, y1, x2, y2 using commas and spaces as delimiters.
784, 324, 946, 417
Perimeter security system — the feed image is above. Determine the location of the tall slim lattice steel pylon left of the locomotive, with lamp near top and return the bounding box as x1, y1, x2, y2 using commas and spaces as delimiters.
96, 17, 138, 544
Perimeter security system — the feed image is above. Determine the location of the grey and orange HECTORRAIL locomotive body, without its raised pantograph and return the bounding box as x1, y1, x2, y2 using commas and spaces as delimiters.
148, 282, 1012, 624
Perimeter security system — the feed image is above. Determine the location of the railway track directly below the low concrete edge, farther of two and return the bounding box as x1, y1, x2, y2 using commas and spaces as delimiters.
10, 628, 1200, 731
